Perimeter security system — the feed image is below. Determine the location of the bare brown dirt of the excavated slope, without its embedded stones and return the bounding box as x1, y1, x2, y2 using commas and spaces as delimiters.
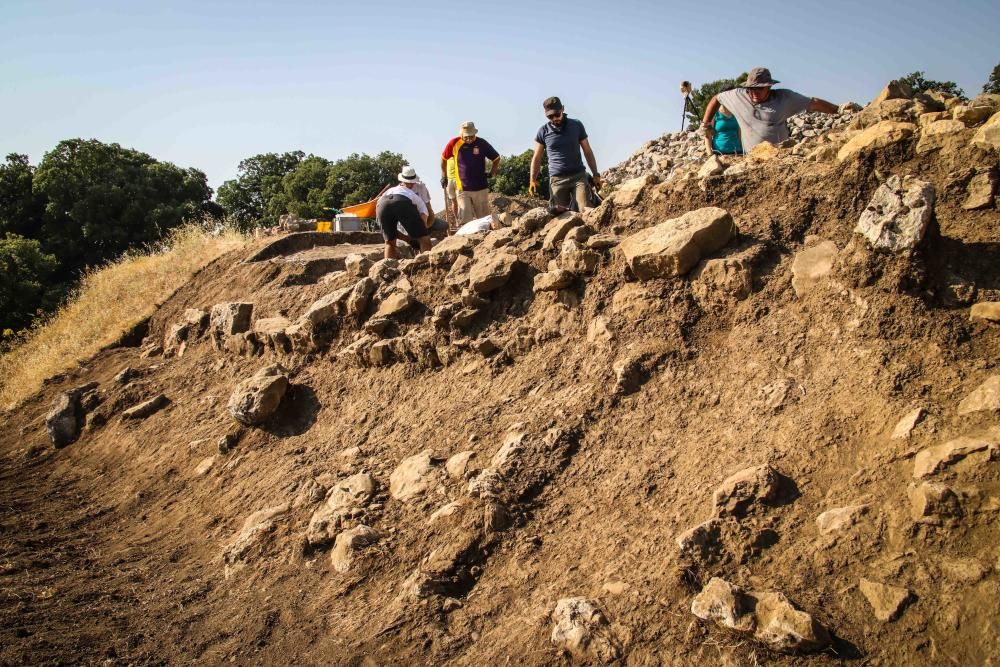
0, 124, 1000, 665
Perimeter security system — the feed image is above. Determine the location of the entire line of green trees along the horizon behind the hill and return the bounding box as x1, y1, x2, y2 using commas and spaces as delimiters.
0, 65, 1000, 346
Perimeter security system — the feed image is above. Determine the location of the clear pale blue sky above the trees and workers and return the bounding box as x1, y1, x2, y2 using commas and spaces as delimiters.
0, 0, 1000, 205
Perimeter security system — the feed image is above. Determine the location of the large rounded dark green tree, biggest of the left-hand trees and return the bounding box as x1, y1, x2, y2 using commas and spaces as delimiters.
33, 139, 212, 278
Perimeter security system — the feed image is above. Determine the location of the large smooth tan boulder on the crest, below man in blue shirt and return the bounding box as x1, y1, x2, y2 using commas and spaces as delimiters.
618, 206, 736, 280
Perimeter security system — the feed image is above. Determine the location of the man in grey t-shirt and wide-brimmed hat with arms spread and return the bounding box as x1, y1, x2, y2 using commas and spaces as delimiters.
702, 67, 837, 153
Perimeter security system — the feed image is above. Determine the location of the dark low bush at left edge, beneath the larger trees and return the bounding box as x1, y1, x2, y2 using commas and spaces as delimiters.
0, 234, 60, 338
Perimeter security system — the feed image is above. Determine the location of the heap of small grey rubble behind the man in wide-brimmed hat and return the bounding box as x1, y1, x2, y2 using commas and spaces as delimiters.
603, 102, 861, 186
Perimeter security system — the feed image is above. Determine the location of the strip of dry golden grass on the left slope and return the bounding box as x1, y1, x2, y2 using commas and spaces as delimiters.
0, 225, 246, 407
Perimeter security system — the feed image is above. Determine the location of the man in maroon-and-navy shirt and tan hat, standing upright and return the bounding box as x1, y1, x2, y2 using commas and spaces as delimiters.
441, 120, 500, 224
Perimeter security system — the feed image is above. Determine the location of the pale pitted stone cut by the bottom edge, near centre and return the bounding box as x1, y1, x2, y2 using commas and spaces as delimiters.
550, 597, 621, 664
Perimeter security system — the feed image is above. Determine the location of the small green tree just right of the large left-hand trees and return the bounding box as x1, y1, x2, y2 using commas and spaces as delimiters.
216, 151, 305, 231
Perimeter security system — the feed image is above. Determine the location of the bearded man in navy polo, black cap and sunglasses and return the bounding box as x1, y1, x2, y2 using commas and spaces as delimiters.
528, 97, 601, 209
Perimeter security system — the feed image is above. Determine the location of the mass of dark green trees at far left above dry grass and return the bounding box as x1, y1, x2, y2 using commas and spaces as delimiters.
0, 144, 221, 331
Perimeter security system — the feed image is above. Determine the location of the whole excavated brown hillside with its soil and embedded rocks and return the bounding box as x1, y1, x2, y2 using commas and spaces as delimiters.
0, 81, 1000, 665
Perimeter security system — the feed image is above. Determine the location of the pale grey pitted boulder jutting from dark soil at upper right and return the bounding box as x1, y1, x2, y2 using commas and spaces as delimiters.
854, 175, 934, 252
